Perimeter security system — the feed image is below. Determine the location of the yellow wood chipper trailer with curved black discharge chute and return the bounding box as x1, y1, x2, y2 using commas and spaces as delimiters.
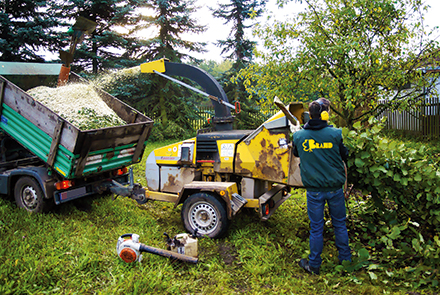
141, 59, 308, 237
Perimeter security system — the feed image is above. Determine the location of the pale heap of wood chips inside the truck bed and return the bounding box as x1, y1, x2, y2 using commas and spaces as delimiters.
27, 83, 126, 130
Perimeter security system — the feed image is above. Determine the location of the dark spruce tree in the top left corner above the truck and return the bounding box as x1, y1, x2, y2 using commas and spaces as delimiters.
0, 0, 61, 62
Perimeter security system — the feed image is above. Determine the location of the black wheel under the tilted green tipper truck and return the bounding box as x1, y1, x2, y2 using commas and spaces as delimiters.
14, 176, 53, 213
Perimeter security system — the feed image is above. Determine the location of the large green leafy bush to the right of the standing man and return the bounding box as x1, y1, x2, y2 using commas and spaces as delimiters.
343, 119, 440, 286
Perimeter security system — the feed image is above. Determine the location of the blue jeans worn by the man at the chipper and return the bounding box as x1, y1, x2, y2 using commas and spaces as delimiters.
307, 189, 351, 268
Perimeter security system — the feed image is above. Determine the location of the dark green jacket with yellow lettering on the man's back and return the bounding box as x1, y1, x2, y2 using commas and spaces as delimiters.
293, 119, 348, 191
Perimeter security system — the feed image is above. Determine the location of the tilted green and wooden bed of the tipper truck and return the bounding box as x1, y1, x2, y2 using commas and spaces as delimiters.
0, 62, 153, 179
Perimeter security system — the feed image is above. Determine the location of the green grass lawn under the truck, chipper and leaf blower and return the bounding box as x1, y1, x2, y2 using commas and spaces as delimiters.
0, 143, 436, 294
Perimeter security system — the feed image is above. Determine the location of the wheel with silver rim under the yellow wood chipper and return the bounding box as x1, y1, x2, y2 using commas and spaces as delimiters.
181, 193, 228, 238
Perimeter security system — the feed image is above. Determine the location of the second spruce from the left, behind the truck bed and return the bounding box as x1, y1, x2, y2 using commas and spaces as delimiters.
51, 0, 146, 74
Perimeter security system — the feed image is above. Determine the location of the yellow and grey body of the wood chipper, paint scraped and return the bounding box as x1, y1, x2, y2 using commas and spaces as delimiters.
146, 104, 303, 215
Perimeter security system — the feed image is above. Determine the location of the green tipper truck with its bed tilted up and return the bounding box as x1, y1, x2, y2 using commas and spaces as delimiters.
0, 62, 153, 212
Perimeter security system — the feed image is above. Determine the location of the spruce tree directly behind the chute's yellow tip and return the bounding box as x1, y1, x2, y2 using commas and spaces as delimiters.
119, 0, 205, 138
